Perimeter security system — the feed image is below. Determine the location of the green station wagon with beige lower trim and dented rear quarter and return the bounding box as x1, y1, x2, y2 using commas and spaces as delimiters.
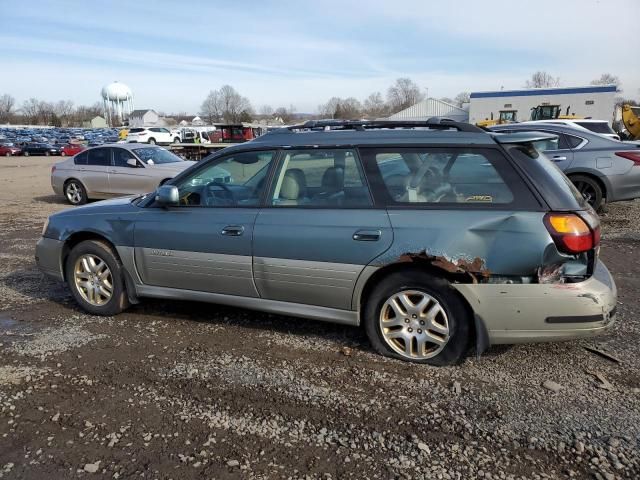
36, 119, 616, 365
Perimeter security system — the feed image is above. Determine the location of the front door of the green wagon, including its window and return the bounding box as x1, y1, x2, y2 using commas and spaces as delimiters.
135, 151, 275, 297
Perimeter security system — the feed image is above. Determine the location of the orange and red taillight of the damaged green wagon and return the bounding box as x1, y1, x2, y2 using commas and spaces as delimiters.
544, 213, 600, 255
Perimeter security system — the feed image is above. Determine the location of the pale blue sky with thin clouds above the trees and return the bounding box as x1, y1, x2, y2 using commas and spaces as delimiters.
0, 0, 640, 114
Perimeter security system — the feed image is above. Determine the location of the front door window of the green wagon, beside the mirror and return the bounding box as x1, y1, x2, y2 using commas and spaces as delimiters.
177, 151, 275, 207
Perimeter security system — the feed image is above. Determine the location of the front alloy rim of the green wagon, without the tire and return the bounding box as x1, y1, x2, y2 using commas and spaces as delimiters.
73, 253, 113, 307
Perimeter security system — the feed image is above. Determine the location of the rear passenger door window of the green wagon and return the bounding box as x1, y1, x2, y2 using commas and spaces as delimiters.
271, 149, 372, 208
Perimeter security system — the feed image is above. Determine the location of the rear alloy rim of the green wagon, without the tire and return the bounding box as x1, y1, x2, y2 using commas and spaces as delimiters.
379, 290, 450, 360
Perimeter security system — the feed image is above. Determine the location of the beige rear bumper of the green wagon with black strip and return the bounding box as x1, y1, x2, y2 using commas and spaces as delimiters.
454, 261, 617, 344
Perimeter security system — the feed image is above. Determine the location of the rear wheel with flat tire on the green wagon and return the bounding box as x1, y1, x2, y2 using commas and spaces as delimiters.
363, 270, 471, 366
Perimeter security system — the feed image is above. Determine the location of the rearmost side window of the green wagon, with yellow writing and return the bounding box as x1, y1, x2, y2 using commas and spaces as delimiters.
361, 148, 538, 208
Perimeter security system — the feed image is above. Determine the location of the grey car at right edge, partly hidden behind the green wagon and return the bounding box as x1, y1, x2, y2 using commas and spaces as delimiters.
491, 123, 640, 210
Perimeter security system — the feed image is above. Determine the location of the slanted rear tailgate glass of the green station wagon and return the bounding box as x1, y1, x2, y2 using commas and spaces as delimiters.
505, 143, 589, 211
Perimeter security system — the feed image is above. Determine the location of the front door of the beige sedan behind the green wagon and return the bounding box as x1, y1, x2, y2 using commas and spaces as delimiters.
109, 147, 158, 195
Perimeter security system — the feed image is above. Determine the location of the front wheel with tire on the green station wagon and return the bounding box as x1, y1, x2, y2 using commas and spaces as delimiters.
65, 240, 130, 316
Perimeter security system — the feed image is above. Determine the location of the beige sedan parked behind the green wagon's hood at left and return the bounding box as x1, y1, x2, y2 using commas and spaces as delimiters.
51, 143, 194, 205
